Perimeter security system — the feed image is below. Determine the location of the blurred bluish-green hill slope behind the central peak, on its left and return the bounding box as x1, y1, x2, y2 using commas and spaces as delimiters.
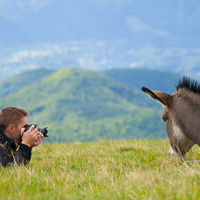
0, 69, 55, 98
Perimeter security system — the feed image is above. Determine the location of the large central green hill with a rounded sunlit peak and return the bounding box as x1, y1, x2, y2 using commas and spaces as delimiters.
0, 68, 160, 123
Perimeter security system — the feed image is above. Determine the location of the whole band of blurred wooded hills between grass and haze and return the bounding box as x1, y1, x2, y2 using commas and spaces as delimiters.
0, 67, 178, 142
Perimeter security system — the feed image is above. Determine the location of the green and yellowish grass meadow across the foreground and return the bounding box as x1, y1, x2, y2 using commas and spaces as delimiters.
0, 140, 200, 200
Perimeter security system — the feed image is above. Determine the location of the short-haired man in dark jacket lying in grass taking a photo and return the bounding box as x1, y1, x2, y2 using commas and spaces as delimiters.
0, 106, 43, 167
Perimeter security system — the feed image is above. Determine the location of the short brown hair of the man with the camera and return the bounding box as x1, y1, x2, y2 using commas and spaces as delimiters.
0, 106, 29, 131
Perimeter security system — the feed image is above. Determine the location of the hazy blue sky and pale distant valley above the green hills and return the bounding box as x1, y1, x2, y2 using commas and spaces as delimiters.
0, 0, 200, 78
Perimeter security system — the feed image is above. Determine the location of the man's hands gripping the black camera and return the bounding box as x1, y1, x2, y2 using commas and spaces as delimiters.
21, 125, 43, 148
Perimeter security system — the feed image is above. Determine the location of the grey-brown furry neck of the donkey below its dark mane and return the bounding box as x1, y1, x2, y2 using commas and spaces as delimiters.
170, 88, 200, 146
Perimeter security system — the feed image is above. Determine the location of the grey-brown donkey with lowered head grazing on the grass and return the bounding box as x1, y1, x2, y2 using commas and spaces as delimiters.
141, 77, 200, 157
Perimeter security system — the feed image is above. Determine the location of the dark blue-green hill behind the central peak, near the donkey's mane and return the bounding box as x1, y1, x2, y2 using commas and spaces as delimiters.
103, 69, 180, 94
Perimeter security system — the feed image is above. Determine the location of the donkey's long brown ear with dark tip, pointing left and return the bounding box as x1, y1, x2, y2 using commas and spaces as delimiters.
141, 87, 173, 106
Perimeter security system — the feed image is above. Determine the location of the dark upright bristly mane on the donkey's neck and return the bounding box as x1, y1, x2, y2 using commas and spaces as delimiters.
175, 76, 200, 94
